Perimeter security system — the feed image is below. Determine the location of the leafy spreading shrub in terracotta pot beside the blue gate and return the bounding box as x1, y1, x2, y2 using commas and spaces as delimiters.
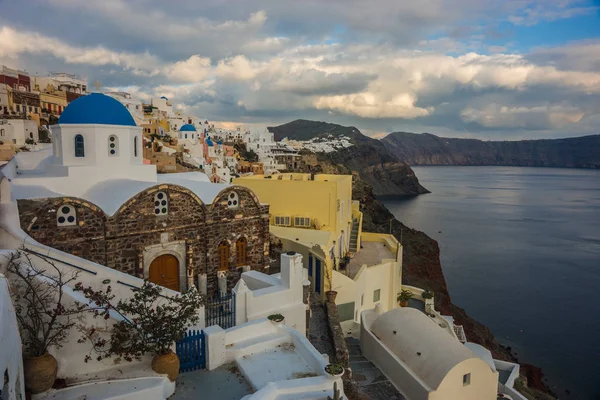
75, 280, 206, 381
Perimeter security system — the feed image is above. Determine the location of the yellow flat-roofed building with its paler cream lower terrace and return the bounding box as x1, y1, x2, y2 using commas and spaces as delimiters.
233, 173, 402, 314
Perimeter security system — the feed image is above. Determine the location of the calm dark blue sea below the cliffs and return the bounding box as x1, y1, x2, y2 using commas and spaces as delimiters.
385, 167, 600, 400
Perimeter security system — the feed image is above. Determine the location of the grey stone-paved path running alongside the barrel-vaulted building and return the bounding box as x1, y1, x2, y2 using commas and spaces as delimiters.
346, 337, 406, 400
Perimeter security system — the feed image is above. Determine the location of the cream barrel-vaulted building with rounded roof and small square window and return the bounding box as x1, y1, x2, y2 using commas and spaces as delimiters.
360, 307, 498, 400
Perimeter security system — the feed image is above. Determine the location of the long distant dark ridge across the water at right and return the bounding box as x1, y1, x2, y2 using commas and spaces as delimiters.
381, 132, 600, 168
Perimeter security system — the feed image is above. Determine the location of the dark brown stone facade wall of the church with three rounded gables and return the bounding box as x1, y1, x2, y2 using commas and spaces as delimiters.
18, 184, 269, 296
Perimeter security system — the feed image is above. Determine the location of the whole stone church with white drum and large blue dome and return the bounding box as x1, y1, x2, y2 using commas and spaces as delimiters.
3, 94, 269, 296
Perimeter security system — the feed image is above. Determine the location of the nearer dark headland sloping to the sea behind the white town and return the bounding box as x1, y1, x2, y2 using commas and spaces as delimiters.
269, 120, 428, 196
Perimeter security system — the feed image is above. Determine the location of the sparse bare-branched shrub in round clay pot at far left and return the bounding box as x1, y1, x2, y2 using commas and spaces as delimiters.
8, 252, 86, 394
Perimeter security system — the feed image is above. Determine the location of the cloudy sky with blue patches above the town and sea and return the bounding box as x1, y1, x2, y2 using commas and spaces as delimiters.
0, 0, 600, 140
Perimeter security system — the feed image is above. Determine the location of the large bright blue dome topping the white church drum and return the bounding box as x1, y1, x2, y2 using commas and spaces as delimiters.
58, 93, 136, 126
